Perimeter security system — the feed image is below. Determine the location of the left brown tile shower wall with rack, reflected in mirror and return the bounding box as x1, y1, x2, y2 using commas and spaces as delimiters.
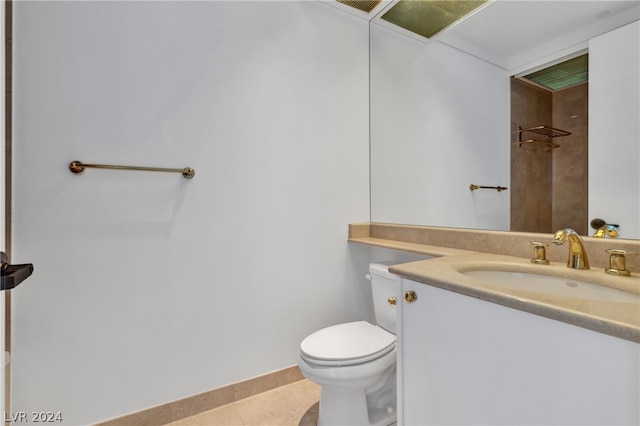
509, 78, 553, 232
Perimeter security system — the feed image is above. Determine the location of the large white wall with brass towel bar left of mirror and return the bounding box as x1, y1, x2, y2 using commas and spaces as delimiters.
12, 1, 369, 424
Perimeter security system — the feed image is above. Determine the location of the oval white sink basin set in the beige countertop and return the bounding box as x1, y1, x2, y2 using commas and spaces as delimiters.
463, 270, 640, 304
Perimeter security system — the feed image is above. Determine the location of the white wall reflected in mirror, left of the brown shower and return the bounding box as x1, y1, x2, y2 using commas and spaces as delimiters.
371, 25, 510, 230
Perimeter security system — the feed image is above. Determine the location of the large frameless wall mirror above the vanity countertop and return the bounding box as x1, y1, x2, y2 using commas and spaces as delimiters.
348, 0, 640, 239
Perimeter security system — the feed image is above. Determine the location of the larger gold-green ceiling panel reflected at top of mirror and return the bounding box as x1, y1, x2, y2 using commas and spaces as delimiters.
382, 0, 486, 38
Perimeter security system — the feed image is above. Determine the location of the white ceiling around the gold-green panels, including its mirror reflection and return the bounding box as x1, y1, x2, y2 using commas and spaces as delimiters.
327, 0, 640, 74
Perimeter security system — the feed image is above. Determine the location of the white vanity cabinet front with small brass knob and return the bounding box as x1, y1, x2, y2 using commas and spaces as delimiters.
398, 279, 640, 425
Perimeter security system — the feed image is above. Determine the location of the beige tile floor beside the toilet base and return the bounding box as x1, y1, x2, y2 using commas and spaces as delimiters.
170, 379, 320, 426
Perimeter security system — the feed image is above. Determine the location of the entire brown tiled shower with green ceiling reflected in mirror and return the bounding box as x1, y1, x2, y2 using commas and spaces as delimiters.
510, 55, 589, 235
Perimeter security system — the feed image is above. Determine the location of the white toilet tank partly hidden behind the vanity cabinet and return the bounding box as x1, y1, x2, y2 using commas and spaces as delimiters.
369, 263, 396, 334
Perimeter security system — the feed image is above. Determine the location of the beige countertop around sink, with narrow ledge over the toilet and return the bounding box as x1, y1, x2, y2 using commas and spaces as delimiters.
349, 225, 640, 343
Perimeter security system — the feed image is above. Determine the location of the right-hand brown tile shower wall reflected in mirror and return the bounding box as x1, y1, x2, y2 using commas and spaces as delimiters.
551, 83, 593, 235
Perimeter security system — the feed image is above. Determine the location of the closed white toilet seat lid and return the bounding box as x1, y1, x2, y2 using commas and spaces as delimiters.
300, 321, 396, 365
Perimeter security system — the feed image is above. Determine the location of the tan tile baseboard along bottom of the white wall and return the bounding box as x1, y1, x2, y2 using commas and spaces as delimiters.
95, 365, 304, 426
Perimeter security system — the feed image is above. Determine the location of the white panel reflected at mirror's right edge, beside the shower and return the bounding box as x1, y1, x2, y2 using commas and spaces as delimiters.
589, 21, 640, 239
